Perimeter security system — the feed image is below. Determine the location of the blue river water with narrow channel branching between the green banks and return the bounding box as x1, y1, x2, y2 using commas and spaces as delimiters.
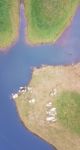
0, 4, 80, 150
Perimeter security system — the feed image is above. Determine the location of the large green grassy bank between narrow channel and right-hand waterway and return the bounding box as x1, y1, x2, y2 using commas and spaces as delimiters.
24, 0, 79, 44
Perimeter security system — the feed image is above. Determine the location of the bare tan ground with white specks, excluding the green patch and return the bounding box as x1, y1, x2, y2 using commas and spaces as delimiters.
15, 64, 80, 150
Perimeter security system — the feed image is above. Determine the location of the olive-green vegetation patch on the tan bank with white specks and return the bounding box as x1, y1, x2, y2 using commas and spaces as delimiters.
55, 91, 80, 134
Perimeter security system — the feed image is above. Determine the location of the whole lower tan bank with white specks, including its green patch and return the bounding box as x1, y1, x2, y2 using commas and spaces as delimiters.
15, 64, 80, 150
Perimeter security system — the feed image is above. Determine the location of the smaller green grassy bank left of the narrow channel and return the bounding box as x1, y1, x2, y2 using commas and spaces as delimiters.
0, 0, 20, 49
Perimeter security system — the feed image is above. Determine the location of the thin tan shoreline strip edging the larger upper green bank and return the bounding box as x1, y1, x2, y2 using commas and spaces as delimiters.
24, 4, 80, 47
